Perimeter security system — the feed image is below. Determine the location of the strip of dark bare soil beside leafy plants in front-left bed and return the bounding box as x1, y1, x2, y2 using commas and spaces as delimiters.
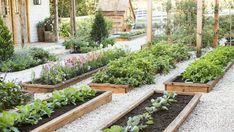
16, 91, 104, 132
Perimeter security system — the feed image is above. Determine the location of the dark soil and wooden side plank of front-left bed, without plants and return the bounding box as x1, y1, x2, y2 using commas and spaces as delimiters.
19, 91, 112, 132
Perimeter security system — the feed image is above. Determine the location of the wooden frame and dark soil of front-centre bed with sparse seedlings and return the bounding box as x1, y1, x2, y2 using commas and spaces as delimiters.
100, 91, 201, 132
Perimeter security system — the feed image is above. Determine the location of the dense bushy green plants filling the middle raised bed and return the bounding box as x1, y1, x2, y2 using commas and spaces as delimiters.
93, 44, 189, 87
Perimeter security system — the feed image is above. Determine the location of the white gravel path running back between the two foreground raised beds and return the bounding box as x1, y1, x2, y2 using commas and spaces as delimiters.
57, 60, 192, 132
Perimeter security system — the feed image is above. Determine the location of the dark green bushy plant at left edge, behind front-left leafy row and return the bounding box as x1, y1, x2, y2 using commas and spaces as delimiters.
0, 80, 31, 111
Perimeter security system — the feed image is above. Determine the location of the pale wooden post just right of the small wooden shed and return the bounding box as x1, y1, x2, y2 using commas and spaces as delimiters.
147, 0, 152, 43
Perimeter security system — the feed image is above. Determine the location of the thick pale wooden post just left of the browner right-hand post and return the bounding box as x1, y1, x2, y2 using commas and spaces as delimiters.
196, 0, 203, 57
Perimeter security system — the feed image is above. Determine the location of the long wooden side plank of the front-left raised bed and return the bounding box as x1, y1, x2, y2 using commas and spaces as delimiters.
31, 91, 112, 132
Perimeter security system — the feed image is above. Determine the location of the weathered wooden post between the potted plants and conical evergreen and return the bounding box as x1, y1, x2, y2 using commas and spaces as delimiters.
70, 0, 76, 37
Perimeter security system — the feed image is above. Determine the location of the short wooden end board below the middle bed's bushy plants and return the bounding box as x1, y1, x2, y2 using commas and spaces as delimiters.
89, 83, 132, 94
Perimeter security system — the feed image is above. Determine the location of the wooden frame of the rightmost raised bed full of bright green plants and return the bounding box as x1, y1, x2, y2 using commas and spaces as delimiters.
164, 61, 234, 93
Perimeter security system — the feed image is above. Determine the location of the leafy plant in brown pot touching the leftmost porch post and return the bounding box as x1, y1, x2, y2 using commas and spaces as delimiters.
44, 17, 55, 42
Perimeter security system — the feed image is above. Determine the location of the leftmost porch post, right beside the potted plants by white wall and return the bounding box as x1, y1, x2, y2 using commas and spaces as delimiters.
54, 0, 59, 42
